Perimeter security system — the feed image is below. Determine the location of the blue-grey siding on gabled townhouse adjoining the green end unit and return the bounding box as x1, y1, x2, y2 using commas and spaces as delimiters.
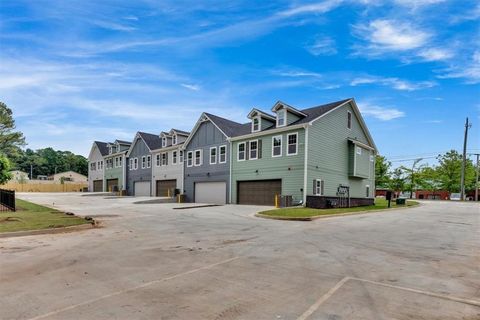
183, 121, 230, 203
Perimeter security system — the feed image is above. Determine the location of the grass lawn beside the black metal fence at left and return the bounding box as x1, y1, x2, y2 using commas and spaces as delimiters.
0, 199, 89, 232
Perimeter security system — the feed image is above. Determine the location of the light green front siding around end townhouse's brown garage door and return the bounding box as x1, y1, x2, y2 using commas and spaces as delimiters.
231, 128, 305, 203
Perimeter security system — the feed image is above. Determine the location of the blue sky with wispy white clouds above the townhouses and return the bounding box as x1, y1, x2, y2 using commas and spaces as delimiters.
0, 0, 480, 165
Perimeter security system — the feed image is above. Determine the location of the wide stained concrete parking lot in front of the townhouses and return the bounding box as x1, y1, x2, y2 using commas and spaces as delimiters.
0, 194, 480, 320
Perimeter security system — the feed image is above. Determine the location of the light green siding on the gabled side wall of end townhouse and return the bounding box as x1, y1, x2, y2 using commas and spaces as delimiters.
307, 103, 375, 198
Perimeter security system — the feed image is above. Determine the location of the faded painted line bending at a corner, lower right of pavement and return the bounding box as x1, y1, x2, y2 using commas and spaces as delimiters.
297, 277, 480, 320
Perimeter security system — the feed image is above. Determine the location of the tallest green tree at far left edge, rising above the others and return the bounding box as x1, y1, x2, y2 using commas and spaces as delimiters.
0, 102, 25, 156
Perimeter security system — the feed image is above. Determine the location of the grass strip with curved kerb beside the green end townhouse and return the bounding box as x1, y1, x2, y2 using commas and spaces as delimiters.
259, 199, 418, 218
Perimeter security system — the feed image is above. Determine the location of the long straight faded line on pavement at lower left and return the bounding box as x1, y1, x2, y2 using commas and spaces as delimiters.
28, 257, 240, 320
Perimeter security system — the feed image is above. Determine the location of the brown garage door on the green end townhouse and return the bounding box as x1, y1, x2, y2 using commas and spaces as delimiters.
237, 180, 282, 206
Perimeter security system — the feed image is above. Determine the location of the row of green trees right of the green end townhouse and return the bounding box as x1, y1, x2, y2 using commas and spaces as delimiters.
375, 150, 477, 193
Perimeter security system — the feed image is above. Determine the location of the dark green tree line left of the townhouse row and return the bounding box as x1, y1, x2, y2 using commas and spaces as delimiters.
0, 102, 88, 184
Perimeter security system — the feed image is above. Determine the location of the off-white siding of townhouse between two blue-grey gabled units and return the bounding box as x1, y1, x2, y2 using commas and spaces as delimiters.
152, 146, 183, 196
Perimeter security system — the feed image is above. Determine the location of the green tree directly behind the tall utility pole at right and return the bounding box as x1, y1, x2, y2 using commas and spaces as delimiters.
437, 150, 475, 192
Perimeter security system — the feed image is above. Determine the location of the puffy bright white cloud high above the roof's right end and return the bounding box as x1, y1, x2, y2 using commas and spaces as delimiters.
354, 19, 431, 51
